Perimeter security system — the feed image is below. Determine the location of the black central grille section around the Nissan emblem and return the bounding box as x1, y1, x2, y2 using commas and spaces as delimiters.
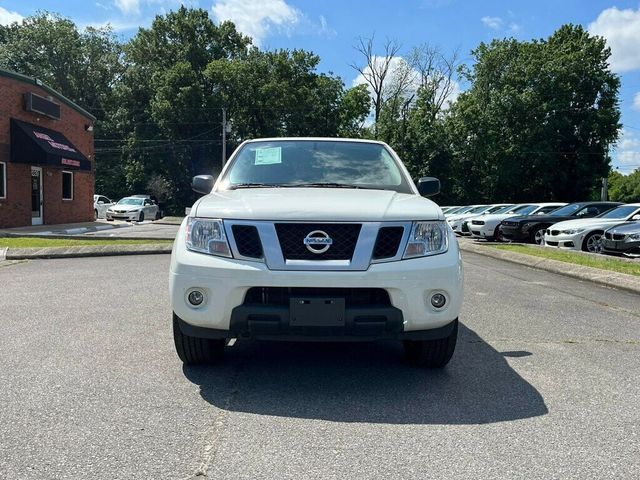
275, 223, 362, 260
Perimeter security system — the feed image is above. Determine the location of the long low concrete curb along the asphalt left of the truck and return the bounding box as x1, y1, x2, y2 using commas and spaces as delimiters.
5, 243, 173, 260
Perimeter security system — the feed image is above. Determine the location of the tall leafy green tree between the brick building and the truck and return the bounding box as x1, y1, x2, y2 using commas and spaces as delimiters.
110, 7, 250, 212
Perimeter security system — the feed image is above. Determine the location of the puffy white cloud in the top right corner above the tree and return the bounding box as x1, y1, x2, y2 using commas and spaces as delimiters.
589, 7, 640, 72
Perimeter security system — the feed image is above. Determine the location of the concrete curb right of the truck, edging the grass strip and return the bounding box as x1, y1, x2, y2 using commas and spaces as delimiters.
458, 242, 640, 294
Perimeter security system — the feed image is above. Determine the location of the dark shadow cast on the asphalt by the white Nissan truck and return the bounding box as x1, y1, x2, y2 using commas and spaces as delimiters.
184, 324, 548, 424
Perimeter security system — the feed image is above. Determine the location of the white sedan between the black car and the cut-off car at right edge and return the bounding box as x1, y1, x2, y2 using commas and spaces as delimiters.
544, 203, 640, 253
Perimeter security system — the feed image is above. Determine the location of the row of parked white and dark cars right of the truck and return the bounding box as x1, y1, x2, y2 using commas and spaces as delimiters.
442, 201, 640, 257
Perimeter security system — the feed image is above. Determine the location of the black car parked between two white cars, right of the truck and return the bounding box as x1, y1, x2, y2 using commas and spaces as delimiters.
500, 202, 622, 245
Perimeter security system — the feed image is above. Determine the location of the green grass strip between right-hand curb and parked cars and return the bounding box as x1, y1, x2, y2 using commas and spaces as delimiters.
491, 245, 640, 276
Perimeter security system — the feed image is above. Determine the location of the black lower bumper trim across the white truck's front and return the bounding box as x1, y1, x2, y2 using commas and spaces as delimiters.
173, 314, 457, 342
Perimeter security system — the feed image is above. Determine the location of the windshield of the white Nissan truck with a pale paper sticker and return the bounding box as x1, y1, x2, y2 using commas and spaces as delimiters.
221, 140, 413, 193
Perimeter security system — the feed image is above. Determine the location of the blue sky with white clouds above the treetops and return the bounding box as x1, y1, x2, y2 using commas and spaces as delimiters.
0, 0, 640, 173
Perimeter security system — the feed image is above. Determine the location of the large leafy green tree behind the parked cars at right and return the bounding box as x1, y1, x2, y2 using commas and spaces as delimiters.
449, 25, 620, 202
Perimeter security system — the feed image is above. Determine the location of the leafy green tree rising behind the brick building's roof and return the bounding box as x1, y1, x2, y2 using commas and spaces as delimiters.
0, 12, 124, 196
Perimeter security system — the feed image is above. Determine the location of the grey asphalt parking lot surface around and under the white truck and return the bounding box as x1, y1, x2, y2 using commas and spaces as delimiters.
0, 253, 640, 479
